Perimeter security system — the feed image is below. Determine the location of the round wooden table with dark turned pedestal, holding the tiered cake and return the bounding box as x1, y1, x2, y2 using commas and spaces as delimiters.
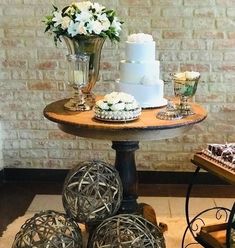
44, 99, 207, 213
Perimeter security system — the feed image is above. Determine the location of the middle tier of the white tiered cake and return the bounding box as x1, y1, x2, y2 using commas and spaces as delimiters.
120, 60, 160, 84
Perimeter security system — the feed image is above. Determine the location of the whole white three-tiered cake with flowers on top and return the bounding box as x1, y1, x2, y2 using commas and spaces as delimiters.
117, 33, 167, 108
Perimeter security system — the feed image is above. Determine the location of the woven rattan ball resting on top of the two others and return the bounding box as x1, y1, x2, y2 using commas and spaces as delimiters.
62, 161, 122, 224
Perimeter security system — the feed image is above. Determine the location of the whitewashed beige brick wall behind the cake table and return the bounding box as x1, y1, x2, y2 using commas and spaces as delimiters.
0, 0, 235, 171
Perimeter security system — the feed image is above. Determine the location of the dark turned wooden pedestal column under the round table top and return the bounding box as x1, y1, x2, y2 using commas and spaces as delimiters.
112, 141, 139, 213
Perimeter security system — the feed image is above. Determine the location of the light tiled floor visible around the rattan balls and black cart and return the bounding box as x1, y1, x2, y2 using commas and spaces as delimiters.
27, 195, 234, 248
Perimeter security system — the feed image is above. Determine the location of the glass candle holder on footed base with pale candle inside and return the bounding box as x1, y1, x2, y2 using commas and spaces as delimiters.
64, 53, 91, 111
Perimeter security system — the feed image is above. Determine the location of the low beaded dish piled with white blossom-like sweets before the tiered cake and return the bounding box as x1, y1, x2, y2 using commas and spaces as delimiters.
94, 92, 141, 121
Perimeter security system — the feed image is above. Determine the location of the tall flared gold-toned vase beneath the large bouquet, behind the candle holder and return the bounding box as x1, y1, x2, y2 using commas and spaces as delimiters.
63, 35, 105, 108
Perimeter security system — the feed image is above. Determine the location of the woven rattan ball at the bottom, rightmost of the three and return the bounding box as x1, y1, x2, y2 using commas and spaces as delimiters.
88, 214, 166, 248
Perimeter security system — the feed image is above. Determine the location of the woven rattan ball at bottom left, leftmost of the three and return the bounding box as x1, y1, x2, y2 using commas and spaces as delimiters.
12, 210, 82, 248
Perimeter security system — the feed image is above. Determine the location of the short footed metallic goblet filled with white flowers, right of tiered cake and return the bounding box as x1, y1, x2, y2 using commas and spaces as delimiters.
172, 71, 200, 116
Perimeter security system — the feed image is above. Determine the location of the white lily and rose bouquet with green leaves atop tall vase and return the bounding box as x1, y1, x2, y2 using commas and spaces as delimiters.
44, 1, 123, 44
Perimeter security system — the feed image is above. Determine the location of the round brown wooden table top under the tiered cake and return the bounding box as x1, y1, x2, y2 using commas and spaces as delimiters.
43, 99, 207, 141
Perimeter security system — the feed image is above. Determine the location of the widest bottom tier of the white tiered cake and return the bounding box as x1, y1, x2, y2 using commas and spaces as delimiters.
116, 80, 167, 108
